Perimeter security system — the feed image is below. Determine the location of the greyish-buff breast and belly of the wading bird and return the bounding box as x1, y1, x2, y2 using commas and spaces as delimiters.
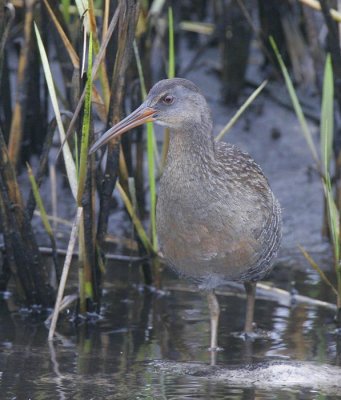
157, 170, 270, 280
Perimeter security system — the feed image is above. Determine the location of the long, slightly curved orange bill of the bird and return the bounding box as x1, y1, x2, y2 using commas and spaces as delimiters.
89, 103, 156, 154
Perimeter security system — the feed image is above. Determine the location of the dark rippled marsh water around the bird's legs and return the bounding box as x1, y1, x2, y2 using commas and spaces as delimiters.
0, 265, 341, 399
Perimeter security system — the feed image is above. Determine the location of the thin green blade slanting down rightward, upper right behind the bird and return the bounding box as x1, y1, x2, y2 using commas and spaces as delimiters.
270, 37, 320, 167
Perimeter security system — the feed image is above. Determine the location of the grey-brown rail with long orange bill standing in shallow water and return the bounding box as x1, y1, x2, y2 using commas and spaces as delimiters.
89, 78, 282, 360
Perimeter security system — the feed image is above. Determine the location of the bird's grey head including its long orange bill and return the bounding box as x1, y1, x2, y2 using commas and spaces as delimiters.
90, 78, 210, 154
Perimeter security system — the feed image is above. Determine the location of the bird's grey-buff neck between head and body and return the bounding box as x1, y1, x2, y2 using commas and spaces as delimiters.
167, 121, 214, 169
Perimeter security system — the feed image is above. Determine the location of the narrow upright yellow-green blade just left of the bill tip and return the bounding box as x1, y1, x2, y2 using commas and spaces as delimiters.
77, 33, 92, 206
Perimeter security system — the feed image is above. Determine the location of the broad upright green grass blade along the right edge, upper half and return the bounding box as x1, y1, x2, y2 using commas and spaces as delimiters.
320, 54, 334, 176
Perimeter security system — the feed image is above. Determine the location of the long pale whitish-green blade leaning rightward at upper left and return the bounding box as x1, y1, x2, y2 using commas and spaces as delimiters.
34, 24, 78, 199
